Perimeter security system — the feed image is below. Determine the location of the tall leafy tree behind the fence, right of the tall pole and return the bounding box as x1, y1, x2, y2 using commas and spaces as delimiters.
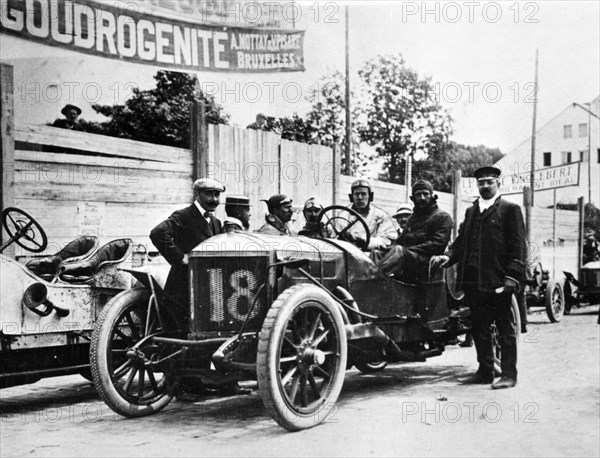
359, 54, 452, 183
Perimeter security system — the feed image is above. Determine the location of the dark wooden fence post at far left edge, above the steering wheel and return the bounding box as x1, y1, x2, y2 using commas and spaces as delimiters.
0, 64, 15, 256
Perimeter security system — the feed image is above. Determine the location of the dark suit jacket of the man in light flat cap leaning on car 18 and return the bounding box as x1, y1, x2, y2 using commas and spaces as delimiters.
150, 204, 221, 304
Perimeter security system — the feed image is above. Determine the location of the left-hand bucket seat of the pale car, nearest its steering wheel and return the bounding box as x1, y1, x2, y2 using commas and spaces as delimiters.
25, 236, 98, 281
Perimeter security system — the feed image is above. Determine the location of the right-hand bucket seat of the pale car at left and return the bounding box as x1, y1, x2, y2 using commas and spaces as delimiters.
59, 239, 133, 286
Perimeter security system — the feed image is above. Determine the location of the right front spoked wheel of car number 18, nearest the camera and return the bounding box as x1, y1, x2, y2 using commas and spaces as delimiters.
257, 284, 348, 431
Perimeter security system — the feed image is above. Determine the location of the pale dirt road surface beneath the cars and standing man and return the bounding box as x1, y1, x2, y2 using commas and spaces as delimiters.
0, 306, 600, 457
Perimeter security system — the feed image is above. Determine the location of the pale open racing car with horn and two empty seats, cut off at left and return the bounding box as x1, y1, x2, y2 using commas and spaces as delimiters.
0, 207, 132, 388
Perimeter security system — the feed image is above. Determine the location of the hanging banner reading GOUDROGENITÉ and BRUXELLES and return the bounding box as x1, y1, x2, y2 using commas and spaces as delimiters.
0, 0, 304, 73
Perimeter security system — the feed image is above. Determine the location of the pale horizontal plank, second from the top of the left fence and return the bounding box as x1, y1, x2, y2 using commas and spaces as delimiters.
15, 150, 192, 177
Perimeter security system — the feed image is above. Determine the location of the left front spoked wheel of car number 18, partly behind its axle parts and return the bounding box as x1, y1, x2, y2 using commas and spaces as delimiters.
90, 289, 173, 417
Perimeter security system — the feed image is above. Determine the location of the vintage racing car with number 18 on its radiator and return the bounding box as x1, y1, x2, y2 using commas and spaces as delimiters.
90, 207, 492, 430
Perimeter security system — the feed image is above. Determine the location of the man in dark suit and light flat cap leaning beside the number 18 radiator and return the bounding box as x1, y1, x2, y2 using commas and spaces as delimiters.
150, 178, 225, 306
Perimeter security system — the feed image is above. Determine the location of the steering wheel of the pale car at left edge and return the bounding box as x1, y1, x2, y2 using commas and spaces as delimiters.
0, 207, 48, 253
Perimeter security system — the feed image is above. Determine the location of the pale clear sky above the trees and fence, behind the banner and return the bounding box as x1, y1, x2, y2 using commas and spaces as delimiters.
0, 1, 600, 153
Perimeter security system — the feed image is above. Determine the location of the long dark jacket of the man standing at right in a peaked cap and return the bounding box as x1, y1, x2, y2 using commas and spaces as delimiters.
446, 197, 526, 292
